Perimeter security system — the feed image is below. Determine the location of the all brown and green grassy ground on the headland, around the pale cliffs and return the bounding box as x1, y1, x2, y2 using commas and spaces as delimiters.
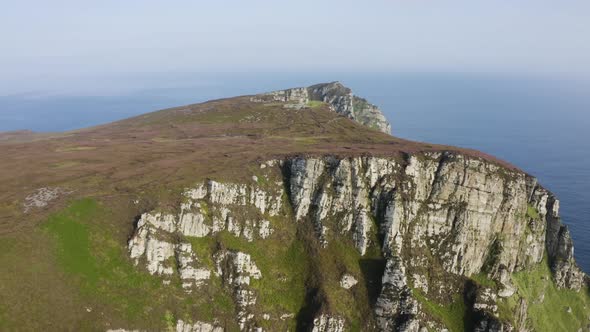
0, 92, 588, 330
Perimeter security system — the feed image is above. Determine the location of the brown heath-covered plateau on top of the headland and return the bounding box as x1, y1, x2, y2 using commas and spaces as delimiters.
0, 96, 513, 233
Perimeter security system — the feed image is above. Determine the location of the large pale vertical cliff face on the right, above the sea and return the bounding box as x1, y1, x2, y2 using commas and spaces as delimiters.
288, 153, 584, 331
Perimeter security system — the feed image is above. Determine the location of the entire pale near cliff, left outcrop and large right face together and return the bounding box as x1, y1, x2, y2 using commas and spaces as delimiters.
129, 152, 585, 331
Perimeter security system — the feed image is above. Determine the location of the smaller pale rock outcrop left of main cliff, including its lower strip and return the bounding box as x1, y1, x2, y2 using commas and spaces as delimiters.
128, 175, 283, 332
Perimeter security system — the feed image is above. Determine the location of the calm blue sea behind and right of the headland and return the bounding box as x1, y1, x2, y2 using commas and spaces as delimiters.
0, 73, 590, 272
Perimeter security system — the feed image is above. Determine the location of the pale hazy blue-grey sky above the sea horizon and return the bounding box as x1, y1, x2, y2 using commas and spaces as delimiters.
0, 0, 590, 93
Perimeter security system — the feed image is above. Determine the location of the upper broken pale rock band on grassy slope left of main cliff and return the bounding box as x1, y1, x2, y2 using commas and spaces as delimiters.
129, 174, 282, 290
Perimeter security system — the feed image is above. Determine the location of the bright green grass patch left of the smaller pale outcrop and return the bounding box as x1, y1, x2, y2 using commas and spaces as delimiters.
42, 199, 197, 326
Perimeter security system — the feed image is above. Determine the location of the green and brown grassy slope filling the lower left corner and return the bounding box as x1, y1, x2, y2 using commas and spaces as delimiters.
0, 199, 238, 331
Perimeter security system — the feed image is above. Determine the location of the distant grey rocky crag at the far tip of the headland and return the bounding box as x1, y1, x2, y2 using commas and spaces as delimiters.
252, 82, 391, 134
